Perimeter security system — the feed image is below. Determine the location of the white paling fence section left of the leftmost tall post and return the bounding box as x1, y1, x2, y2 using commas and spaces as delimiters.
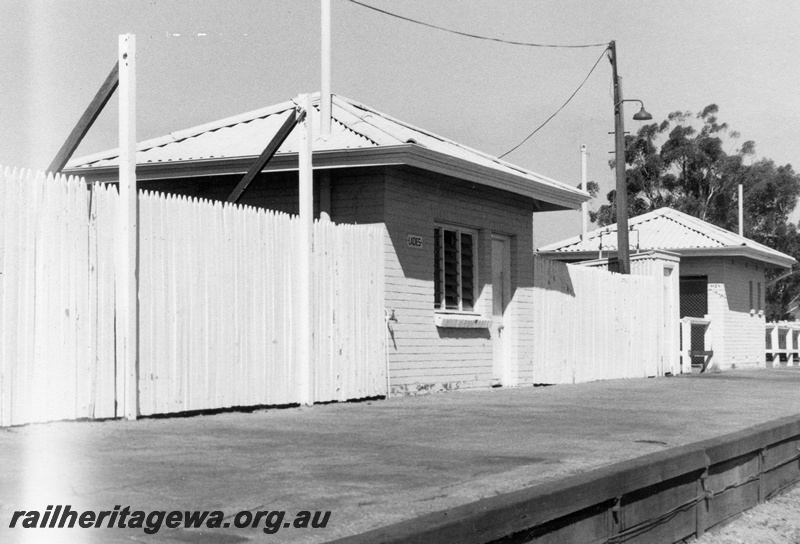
0, 169, 117, 426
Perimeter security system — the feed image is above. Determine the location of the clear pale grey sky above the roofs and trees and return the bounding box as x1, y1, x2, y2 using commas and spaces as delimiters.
0, 0, 800, 247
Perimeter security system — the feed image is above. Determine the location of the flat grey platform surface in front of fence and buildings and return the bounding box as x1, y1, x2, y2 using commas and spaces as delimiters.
0, 368, 800, 543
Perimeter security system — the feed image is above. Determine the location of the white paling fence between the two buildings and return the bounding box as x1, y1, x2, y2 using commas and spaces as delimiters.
533, 257, 668, 384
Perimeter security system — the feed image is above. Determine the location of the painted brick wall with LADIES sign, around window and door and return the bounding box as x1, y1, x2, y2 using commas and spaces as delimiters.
378, 168, 533, 394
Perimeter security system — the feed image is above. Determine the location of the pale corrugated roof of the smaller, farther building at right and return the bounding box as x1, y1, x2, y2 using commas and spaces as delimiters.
538, 208, 796, 266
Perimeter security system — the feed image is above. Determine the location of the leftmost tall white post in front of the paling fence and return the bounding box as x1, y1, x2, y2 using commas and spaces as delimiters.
118, 34, 139, 420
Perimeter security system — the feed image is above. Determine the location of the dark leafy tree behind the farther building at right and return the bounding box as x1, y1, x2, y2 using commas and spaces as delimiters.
591, 104, 800, 320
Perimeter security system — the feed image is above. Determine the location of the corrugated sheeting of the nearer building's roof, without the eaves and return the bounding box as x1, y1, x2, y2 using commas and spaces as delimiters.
67, 93, 588, 206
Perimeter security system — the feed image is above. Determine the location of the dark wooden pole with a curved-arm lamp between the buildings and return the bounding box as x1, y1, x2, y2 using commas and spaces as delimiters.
609, 41, 653, 274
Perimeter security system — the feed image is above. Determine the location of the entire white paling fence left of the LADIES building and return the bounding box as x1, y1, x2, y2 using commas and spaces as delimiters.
0, 170, 386, 426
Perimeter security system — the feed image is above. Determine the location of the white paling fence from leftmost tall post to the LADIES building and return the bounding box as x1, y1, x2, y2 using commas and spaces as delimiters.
139, 193, 386, 414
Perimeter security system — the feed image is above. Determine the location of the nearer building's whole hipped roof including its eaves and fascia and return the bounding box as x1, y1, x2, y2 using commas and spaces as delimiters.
65, 91, 590, 209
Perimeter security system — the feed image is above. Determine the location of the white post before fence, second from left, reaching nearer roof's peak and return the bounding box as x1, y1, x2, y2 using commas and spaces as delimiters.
297, 95, 314, 405
